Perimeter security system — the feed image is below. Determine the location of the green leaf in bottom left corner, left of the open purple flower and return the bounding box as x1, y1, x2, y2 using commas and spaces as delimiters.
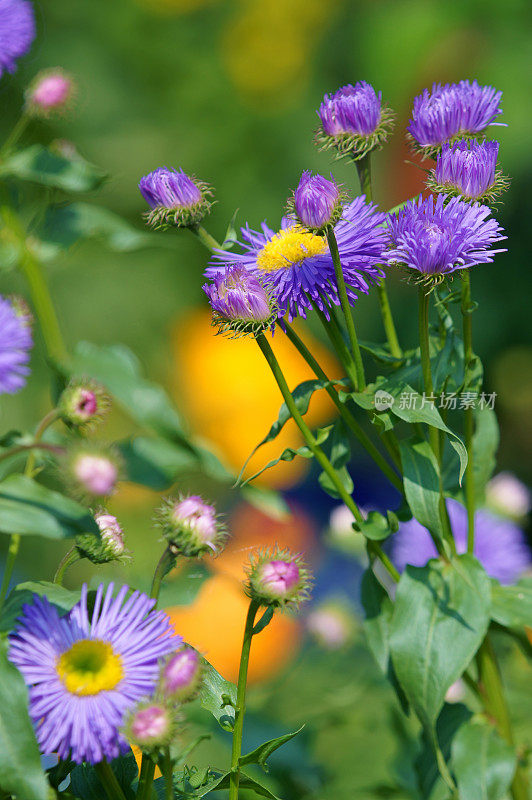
0, 642, 48, 800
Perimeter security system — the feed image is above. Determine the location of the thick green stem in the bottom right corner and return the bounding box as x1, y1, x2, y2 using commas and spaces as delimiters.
477, 635, 529, 800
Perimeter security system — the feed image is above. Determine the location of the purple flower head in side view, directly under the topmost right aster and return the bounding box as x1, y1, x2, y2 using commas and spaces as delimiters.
427, 139, 508, 203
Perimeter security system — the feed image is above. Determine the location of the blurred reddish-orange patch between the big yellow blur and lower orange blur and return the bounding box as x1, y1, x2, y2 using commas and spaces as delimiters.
210, 503, 316, 580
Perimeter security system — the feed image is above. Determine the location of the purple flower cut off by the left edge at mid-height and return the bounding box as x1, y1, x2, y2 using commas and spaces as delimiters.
0, 295, 33, 394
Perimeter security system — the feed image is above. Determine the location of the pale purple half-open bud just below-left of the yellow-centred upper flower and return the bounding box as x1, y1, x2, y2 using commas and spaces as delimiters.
203, 265, 278, 338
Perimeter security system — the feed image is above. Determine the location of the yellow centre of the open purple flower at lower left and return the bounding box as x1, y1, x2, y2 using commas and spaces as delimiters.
56, 639, 124, 695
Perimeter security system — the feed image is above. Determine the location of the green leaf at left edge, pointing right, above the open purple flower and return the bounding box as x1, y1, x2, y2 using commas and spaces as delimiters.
0, 475, 100, 539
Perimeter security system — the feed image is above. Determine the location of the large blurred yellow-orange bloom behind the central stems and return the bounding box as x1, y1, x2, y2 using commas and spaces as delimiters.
173, 309, 342, 488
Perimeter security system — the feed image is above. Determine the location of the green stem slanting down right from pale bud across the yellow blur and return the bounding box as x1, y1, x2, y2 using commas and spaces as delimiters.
257, 333, 399, 581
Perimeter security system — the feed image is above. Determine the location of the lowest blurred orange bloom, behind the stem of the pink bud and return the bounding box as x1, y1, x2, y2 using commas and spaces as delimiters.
166, 575, 301, 683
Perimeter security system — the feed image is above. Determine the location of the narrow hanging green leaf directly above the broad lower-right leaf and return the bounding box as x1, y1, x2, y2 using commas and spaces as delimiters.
399, 439, 443, 539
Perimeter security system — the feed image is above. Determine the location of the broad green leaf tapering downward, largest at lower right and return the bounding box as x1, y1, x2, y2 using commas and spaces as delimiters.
390, 555, 491, 728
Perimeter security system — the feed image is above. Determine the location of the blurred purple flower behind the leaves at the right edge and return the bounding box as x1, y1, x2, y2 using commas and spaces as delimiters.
391, 500, 532, 584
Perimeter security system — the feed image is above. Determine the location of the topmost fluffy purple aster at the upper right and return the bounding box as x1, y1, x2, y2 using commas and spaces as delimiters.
408, 81, 504, 157
